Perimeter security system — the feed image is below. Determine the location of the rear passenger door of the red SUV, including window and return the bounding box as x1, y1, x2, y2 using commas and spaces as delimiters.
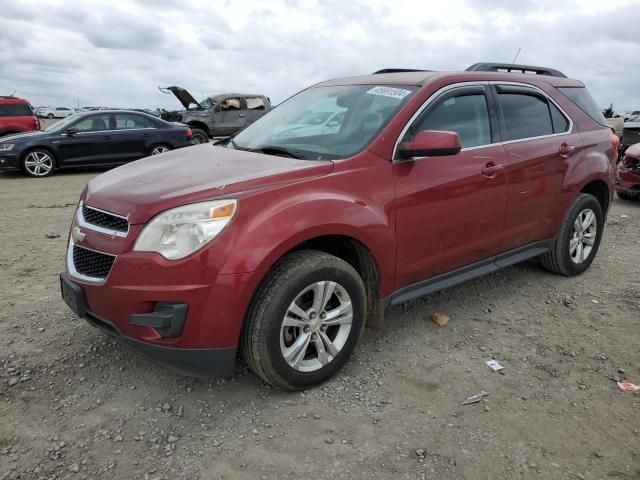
492, 84, 582, 252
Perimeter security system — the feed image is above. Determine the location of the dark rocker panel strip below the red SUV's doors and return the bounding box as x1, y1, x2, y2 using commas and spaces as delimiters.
389, 240, 553, 305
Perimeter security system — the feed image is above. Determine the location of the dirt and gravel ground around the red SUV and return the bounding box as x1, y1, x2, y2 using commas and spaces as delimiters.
0, 171, 640, 480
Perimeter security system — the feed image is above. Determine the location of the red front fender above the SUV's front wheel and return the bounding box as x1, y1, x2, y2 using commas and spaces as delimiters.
206, 156, 396, 295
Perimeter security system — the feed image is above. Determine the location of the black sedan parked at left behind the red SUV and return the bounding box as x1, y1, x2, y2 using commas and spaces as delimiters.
0, 110, 193, 177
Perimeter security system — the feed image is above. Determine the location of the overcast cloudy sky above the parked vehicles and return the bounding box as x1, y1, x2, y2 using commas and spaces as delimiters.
0, 0, 640, 111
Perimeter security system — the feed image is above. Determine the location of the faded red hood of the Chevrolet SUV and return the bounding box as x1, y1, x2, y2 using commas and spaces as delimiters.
83, 144, 333, 224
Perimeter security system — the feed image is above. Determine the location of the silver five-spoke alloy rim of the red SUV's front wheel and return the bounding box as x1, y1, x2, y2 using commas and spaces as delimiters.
280, 281, 353, 372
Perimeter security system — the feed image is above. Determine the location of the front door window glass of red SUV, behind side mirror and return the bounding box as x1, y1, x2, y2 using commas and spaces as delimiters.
403, 93, 491, 148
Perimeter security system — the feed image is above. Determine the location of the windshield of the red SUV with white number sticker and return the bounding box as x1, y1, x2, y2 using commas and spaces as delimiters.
227, 85, 417, 160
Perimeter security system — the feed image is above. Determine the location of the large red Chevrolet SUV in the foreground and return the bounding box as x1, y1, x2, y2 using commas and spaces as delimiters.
61, 64, 618, 390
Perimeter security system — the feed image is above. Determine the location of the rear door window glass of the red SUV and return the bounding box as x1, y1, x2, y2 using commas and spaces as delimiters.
498, 93, 553, 141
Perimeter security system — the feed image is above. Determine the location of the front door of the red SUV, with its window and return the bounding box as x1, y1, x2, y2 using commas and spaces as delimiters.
393, 85, 507, 288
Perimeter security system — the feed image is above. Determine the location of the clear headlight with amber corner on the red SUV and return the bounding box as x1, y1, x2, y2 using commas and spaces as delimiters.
133, 200, 238, 260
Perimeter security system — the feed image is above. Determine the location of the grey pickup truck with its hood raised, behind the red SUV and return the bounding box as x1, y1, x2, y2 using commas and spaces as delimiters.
159, 87, 271, 144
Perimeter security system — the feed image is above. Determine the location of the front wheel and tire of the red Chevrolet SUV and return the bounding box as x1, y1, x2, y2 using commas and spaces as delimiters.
241, 250, 367, 391
